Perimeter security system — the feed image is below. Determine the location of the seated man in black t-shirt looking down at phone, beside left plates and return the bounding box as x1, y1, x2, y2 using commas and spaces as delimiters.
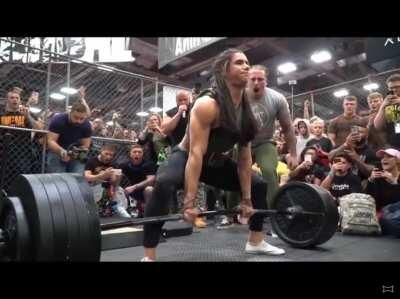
84, 144, 131, 218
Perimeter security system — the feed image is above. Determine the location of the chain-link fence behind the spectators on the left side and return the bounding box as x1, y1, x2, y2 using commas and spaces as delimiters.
0, 38, 188, 190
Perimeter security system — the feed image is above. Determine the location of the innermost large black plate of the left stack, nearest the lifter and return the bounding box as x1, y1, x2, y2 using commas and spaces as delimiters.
72, 174, 101, 260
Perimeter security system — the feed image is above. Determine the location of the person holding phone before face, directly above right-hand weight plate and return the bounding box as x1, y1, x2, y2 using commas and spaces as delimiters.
289, 146, 329, 186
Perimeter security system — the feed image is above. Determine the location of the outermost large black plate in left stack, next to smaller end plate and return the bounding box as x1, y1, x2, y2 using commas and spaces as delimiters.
8, 174, 55, 261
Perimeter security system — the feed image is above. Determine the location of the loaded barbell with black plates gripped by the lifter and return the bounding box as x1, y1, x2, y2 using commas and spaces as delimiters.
0, 173, 339, 261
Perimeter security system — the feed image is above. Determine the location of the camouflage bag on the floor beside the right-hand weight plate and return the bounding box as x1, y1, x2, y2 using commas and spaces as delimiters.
339, 193, 381, 235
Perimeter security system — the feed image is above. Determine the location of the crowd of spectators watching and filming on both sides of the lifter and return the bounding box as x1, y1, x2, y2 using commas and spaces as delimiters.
0, 69, 400, 238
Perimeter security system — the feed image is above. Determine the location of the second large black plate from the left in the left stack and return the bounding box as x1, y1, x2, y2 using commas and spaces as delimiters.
37, 174, 68, 261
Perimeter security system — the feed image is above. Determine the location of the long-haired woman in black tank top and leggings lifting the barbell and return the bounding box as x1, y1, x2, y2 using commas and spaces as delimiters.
142, 49, 285, 261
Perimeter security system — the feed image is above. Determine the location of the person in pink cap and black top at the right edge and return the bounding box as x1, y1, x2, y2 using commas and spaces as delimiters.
365, 148, 400, 213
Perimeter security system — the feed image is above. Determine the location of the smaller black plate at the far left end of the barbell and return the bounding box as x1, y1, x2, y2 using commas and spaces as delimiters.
0, 197, 32, 261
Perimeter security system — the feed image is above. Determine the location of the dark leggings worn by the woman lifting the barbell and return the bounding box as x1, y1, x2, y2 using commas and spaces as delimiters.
143, 147, 267, 248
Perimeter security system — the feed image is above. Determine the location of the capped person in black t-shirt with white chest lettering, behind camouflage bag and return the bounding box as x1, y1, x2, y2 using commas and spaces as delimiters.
321, 152, 362, 203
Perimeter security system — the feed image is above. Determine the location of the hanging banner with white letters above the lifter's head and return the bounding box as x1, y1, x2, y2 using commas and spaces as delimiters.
158, 37, 225, 69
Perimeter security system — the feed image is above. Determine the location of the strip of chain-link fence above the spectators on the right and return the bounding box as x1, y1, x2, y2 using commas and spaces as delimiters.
287, 68, 400, 121
